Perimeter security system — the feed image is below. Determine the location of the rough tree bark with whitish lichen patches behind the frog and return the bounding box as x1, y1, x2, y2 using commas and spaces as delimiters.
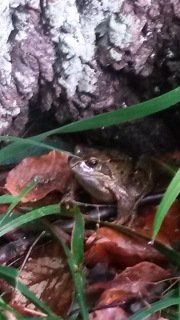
0, 0, 180, 152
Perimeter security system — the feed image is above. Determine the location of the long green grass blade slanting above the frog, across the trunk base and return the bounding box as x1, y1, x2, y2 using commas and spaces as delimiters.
0, 87, 180, 165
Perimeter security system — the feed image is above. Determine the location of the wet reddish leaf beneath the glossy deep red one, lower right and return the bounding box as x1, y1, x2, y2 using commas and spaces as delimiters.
94, 261, 170, 307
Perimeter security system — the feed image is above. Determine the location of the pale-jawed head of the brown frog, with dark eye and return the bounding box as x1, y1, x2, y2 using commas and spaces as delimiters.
69, 147, 114, 202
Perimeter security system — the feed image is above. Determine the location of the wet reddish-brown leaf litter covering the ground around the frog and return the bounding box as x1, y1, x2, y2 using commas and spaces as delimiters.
0, 151, 180, 320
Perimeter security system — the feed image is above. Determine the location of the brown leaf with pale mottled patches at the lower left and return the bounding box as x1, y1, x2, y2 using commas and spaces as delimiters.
10, 243, 73, 316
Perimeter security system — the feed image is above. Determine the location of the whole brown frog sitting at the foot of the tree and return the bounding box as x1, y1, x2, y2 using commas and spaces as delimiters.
70, 146, 153, 223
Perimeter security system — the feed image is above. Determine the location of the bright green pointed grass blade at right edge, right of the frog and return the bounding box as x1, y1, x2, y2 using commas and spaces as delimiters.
152, 169, 180, 241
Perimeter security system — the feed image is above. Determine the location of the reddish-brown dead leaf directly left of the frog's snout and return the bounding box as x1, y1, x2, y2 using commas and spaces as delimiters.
5, 150, 72, 202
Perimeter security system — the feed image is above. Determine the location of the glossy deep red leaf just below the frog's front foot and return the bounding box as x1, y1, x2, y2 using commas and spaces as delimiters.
85, 227, 165, 267
